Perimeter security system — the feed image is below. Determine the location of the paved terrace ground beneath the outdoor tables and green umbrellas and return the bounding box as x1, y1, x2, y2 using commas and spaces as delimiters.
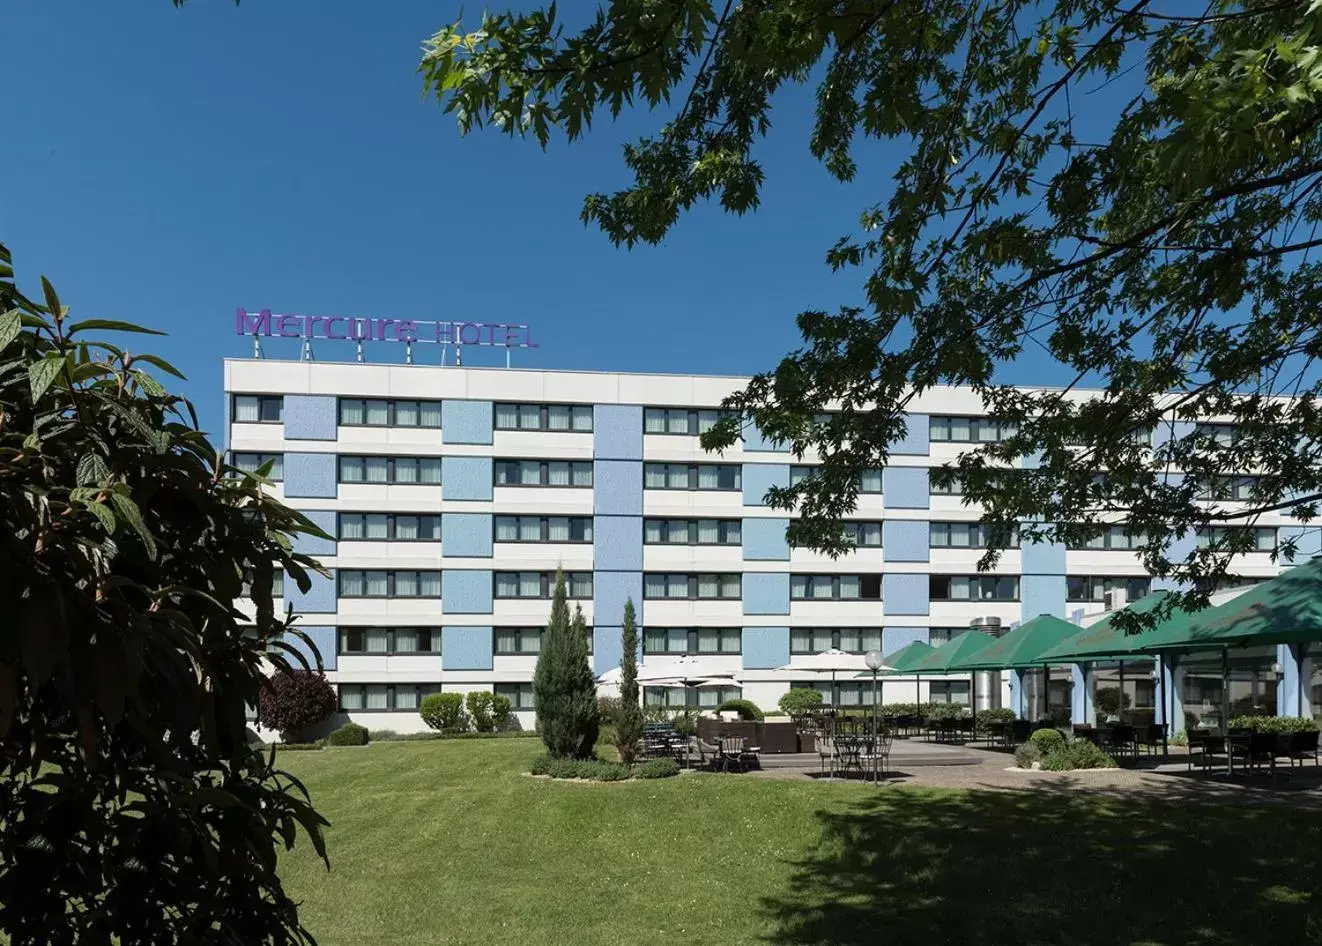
748, 741, 1322, 810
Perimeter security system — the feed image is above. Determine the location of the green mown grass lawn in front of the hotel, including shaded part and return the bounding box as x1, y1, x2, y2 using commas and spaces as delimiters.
273, 740, 1322, 946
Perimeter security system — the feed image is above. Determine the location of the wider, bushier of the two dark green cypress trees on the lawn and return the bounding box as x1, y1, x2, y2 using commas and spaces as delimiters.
533, 571, 599, 758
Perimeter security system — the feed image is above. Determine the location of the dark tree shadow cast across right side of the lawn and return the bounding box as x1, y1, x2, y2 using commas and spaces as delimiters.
763, 790, 1322, 946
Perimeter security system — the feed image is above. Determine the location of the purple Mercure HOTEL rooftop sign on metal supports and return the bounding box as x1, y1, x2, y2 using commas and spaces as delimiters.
234, 309, 538, 363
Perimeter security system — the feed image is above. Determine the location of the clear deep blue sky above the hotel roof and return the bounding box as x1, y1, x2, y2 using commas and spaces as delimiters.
0, 0, 1084, 431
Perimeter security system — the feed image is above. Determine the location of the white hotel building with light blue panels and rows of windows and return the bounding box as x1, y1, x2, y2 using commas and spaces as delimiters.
225, 358, 1322, 732
